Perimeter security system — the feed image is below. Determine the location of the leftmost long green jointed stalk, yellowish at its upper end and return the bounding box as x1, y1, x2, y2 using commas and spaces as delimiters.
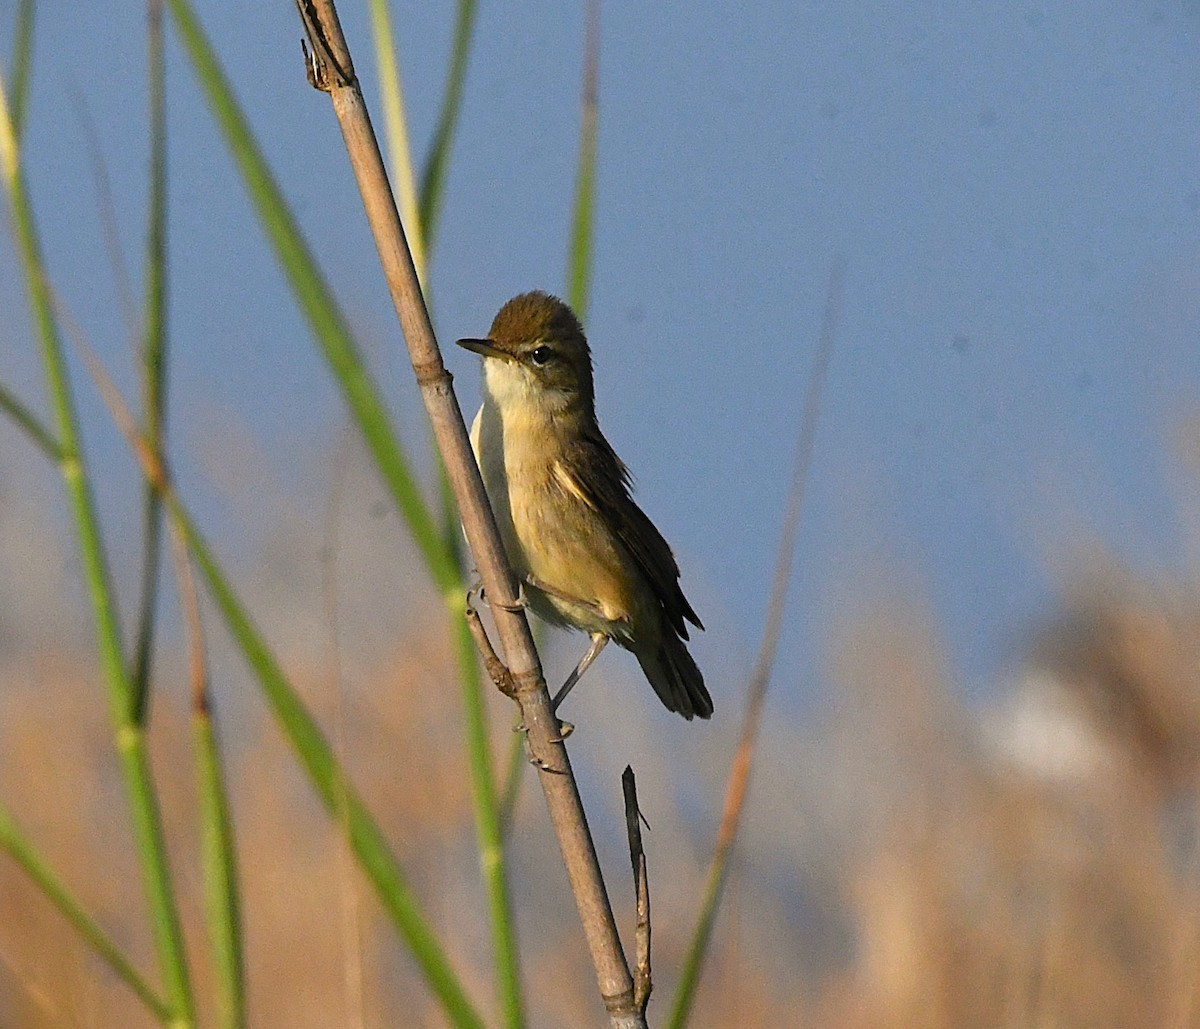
0, 76, 194, 1025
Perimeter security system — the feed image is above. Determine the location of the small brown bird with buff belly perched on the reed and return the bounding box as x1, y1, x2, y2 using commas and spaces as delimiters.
458, 293, 713, 721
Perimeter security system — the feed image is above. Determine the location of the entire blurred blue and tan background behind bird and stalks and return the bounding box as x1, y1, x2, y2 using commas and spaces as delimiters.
0, 0, 1200, 1027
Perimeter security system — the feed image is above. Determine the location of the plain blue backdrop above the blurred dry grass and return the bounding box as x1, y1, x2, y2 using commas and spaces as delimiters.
0, 0, 1200, 704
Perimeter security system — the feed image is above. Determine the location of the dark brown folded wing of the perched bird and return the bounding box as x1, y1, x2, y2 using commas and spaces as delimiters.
556, 424, 704, 639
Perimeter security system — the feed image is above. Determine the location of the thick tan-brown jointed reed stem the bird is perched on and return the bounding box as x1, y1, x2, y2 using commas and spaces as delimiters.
296, 0, 646, 1027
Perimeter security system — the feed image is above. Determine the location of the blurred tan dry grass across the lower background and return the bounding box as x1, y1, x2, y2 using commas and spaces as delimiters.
0, 436, 1200, 1029
